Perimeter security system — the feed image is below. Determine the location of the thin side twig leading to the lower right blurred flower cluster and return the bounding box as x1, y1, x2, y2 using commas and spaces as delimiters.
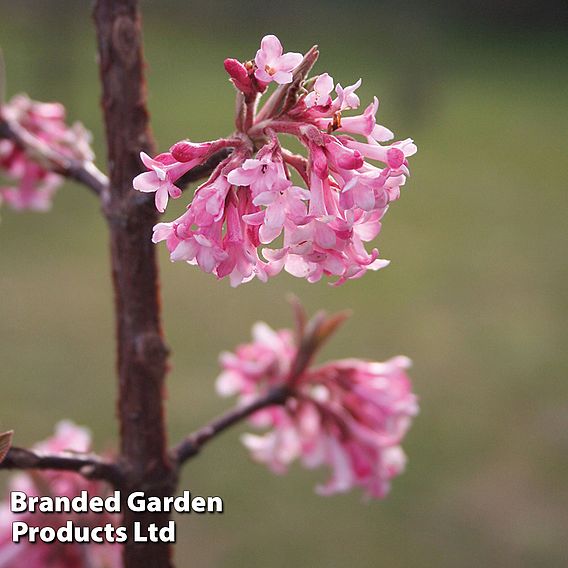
171, 387, 290, 466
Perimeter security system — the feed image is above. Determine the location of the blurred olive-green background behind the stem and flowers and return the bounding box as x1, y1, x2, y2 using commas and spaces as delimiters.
0, 0, 568, 568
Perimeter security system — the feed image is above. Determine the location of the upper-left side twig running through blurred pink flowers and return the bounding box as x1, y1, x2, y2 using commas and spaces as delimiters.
0, 120, 108, 195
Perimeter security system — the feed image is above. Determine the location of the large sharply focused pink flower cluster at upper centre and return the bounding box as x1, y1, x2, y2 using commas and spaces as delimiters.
134, 35, 416, 286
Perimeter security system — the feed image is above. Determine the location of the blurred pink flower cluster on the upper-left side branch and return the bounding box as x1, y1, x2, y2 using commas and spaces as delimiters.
0, 95, 94, 211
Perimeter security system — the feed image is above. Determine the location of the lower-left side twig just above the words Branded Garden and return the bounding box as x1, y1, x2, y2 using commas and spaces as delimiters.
0, 447, 122, 486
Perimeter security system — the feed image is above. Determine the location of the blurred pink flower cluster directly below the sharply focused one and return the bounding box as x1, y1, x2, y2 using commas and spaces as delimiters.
217, 323, 418, 498
